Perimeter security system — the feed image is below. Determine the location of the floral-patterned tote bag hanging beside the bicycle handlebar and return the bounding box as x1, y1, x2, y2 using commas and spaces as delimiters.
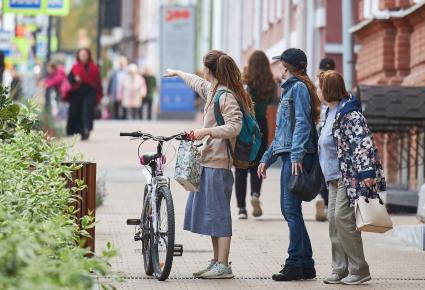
174, 140, 201, 192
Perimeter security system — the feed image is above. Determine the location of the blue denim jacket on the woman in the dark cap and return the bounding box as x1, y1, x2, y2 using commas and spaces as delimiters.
261, 77, 317, 166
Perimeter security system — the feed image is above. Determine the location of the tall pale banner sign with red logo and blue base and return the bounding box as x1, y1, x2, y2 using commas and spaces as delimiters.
160, 6, 195, 112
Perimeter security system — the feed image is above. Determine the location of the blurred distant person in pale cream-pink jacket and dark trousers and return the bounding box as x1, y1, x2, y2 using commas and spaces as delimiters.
118, 63, 146, 120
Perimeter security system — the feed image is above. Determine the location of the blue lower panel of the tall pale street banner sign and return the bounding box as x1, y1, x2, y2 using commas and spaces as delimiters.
160, 77, 195, 112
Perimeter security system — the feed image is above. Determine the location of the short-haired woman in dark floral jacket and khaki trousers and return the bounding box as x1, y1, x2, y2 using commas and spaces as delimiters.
318, 71, 386, 285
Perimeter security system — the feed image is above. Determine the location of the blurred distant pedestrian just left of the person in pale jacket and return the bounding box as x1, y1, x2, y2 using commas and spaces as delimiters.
107, 56, 128, 119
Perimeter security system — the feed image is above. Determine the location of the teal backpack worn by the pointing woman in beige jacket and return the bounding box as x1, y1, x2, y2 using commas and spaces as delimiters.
214, 90, 261, 169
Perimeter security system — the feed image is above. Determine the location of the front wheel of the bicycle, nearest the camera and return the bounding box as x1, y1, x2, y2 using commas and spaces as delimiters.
152, 186, 175, 281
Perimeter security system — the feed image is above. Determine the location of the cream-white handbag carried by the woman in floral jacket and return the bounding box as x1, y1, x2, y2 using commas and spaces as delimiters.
354, 195, 393, 233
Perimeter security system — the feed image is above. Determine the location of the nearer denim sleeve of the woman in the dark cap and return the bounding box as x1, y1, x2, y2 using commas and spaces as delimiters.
291, 82, 311, 163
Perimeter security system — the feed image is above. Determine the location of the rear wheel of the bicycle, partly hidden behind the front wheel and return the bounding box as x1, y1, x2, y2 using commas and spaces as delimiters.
141, 194, 154, 276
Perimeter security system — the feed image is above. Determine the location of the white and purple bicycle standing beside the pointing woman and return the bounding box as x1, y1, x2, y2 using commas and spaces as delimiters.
120, 131, 190, 281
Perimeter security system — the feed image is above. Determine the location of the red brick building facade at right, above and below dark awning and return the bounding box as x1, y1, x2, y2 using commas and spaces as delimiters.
352, 0, 425, 190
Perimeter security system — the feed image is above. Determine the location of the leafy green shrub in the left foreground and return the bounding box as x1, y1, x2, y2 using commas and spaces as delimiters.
0, 88, 115, 290
